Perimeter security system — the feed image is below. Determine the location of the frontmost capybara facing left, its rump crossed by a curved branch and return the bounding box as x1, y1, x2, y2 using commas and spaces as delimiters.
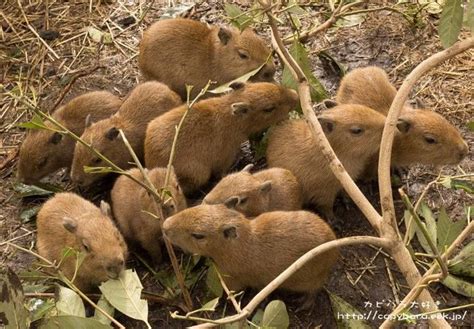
163, 205, 338, 293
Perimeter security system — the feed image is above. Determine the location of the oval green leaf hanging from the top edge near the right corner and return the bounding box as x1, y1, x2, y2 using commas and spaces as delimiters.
438, 0, 463, 48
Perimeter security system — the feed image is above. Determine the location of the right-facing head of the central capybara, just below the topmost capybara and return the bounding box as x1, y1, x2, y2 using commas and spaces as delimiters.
229, 82, 299, 134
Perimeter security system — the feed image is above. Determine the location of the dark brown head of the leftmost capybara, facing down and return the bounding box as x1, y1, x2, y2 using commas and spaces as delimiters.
18, 130, 70, 184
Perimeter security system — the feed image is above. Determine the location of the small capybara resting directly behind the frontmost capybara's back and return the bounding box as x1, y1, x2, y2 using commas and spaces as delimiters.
202, 165, 303, 217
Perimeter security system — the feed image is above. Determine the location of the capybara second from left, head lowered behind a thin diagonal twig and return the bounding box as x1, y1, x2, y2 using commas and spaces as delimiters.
71, 81, 182, 186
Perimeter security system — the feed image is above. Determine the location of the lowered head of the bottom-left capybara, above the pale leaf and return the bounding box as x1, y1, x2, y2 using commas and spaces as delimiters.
63, 202, 127, 284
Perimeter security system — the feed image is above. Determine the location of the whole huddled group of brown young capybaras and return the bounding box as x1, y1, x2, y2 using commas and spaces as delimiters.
18, 19, 468, 304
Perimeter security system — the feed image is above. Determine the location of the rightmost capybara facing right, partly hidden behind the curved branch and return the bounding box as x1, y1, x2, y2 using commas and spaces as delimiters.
336, 66, 469, 179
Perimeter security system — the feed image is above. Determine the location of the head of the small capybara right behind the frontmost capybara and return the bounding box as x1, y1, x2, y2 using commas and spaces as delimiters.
202, 165, 272, 217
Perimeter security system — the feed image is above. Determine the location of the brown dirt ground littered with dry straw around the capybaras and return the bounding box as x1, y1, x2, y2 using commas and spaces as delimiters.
0, 0, 474, 328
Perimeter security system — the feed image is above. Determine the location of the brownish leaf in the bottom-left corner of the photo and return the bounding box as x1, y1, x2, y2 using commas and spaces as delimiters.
0, 266, 29, 328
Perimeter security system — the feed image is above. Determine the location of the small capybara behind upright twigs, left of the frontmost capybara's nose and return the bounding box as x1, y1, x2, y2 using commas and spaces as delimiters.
111, 168, 186, 264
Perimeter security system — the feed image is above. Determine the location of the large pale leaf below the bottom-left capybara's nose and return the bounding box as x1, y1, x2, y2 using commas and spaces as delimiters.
99, 269, 151, 328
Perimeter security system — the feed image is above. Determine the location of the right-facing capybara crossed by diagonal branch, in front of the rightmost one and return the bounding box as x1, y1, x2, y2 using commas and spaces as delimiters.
267, 104, 385, 217
